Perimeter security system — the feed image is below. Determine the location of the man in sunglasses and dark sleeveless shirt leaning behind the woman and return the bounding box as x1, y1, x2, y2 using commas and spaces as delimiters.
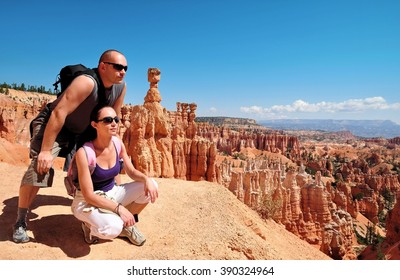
13, 50, 128, 243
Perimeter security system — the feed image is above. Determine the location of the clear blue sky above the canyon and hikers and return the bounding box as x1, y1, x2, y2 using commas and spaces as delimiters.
0, 0, 400, 124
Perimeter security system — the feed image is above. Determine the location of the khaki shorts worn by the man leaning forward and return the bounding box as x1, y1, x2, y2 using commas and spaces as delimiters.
21, 109, 71, 188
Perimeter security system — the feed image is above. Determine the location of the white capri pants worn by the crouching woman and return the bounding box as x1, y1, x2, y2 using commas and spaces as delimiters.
71, 178, 158, 239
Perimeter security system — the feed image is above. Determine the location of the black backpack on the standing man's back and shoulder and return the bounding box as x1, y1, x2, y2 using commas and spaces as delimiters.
53, 64, 105, 104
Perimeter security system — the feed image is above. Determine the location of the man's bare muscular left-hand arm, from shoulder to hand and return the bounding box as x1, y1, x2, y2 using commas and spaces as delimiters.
37, 75, 94, 174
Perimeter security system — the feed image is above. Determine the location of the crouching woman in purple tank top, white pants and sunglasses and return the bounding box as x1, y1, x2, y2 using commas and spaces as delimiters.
71, 106, 158, 246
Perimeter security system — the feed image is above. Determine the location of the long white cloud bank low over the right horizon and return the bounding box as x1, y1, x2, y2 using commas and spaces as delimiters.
240, 96, 400, 116
